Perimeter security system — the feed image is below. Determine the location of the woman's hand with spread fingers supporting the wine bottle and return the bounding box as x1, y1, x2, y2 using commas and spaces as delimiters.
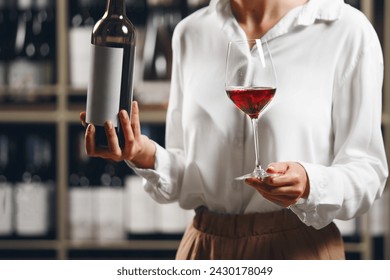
80, 101, 156, 168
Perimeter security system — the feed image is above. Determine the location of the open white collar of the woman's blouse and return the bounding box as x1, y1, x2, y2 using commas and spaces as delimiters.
208, 0, 344, 40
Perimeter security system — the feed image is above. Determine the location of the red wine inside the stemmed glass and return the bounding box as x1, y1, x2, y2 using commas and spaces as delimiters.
226, 87, 276, 119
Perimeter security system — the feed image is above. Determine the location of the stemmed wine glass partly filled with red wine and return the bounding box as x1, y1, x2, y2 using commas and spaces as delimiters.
225, 39, 276, 180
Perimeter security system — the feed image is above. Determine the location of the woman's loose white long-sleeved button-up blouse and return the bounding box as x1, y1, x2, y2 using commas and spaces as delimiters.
128, 0, 388, 228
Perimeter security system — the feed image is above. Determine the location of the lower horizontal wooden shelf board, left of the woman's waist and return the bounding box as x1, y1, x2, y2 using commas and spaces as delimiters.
0, 239, 180, 250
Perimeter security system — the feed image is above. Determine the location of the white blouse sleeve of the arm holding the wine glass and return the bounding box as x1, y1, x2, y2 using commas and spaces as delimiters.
292, 30, 388, 228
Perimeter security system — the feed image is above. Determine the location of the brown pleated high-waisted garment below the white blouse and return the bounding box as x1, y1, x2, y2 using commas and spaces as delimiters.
176, 207, 345, 260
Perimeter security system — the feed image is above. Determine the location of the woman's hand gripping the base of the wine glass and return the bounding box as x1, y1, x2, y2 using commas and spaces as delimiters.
245, 162, 310, 207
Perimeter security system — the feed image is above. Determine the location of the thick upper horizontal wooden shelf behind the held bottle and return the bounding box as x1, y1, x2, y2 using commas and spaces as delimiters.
0, 83, 167, 123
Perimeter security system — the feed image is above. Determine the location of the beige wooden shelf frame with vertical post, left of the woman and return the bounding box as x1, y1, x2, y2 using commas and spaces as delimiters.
0, 0, 171, 259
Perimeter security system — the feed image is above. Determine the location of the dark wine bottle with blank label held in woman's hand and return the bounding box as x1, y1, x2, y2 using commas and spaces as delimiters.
86, 0, 136, 147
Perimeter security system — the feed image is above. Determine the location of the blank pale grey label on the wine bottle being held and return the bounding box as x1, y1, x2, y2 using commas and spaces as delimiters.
86, 44, 123, 127
